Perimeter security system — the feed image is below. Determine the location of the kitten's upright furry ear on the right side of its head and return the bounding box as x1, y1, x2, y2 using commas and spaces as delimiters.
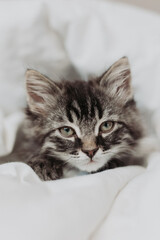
100, 57, 133, 103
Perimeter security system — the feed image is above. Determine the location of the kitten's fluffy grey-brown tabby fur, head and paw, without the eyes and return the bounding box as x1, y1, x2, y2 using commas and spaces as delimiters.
0, 57, 144, 180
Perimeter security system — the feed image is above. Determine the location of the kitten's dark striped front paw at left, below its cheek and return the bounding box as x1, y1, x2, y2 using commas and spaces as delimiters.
27, 157, 63, 181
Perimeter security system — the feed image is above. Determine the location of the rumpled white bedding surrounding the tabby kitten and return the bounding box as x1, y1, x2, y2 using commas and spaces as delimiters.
0, 0, 160, 240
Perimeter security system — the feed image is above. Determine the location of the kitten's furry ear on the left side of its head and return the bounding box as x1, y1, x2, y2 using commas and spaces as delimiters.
26, 69, 60, 115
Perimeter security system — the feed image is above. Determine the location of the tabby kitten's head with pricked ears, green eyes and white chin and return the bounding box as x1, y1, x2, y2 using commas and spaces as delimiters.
26, 57, 142, 172
